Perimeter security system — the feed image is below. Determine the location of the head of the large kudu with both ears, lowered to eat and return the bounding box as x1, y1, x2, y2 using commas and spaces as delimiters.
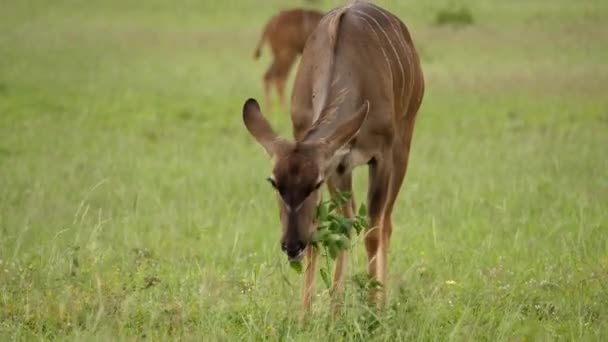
243, 99, 369, 261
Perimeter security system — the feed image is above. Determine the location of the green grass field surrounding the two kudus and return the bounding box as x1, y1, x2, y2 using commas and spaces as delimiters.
0, 0, 608, 341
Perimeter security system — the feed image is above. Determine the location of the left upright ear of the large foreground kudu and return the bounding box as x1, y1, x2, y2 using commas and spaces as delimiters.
243, 99, 282, 157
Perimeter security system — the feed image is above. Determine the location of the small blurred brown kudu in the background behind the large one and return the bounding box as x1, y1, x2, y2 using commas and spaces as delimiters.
254, 8, 323, 111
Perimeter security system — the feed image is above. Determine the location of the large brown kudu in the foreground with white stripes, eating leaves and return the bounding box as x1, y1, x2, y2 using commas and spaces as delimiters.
243, 2, 424, 311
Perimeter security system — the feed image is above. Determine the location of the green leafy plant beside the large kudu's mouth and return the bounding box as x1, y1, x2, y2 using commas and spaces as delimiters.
290, 192, 367, 288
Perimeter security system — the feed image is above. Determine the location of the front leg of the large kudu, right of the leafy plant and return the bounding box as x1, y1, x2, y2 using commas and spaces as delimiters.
365, 158, 391, 302
